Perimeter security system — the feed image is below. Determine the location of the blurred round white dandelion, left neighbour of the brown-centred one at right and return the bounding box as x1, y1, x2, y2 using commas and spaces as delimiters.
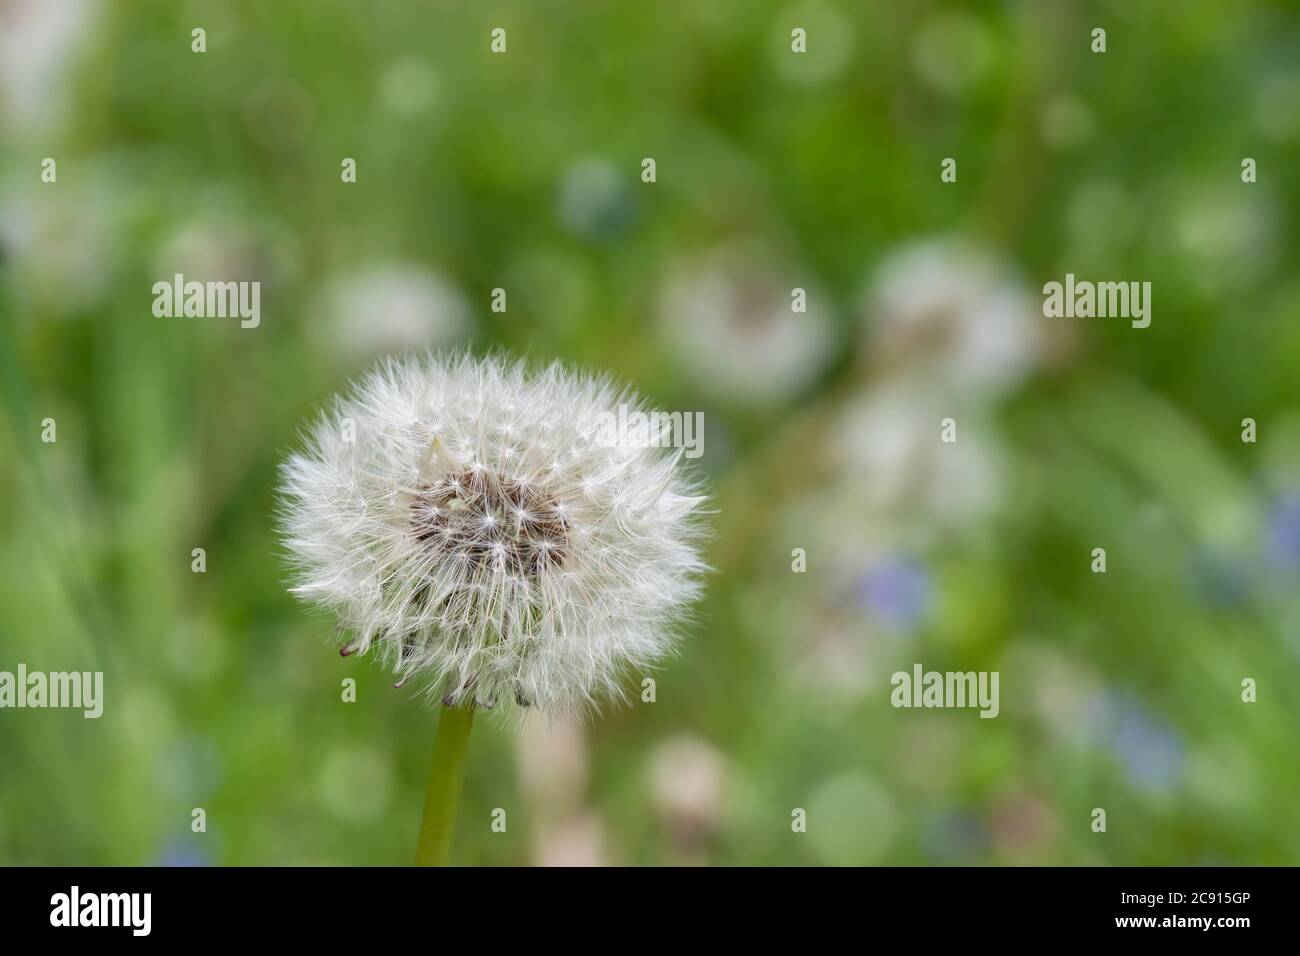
659, 247, 833, 405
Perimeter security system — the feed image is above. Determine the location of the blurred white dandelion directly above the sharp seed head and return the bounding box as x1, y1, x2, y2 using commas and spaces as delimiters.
319, 261, 473, 362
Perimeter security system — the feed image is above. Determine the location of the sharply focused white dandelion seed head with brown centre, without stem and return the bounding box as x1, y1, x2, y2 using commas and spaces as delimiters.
281, 354, 705, 713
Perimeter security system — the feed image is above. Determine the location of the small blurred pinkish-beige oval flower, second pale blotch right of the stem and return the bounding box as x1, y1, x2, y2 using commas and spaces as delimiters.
649, 735, 731, 851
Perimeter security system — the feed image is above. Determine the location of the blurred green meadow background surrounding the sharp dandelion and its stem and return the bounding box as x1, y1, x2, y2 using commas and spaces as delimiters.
0, 0, 1300, 865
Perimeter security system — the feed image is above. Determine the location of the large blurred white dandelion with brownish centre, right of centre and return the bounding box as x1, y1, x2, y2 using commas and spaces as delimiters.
866, 239, 1043, 403
